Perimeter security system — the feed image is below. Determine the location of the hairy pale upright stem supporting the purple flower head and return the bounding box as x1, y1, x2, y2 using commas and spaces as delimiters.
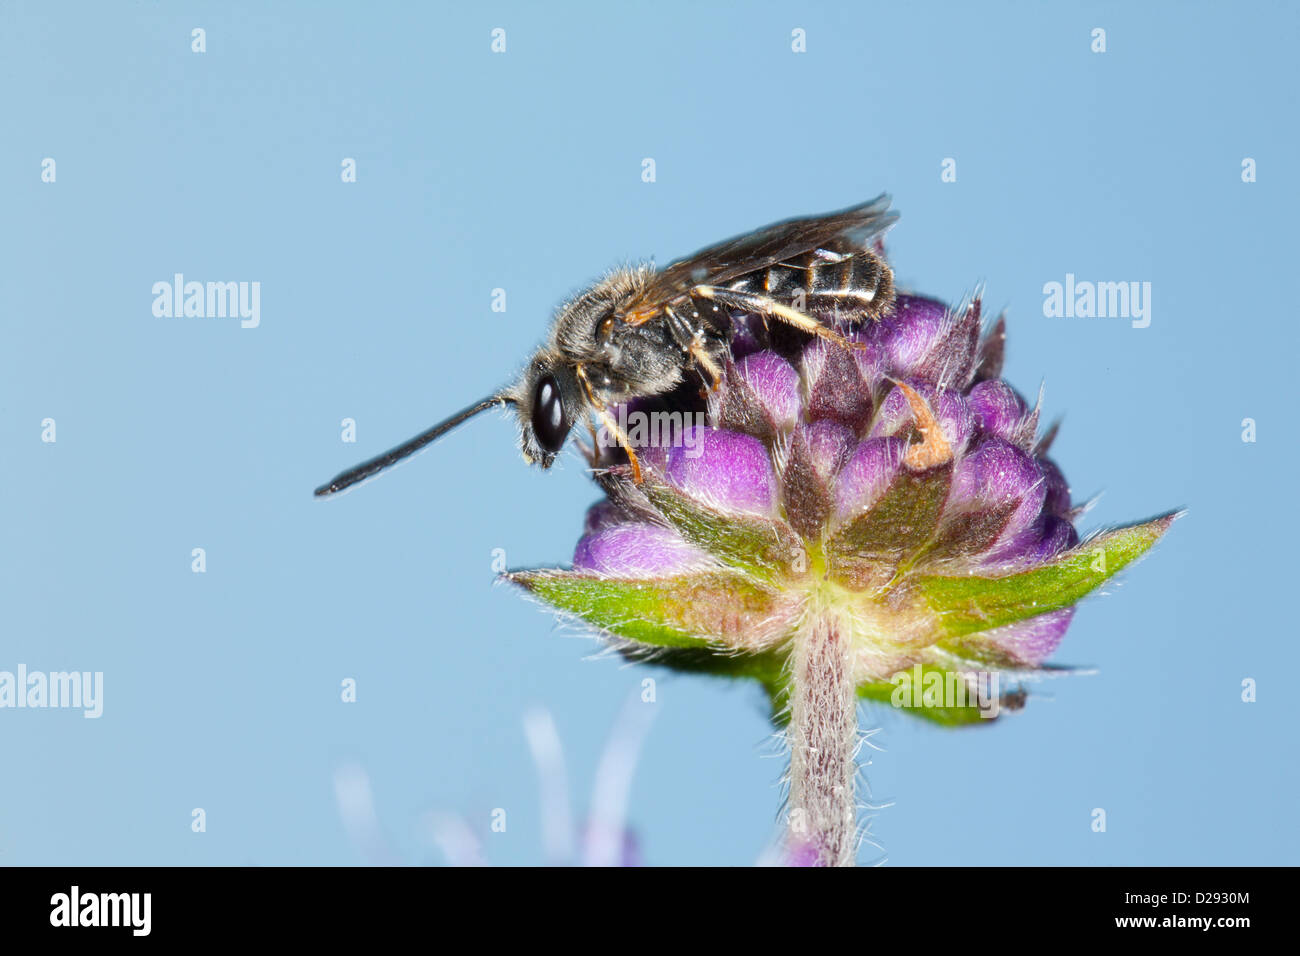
788, 613, 858, 866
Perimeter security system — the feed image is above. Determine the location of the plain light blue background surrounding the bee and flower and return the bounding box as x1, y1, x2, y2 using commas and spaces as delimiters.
0, 0, 1300, 864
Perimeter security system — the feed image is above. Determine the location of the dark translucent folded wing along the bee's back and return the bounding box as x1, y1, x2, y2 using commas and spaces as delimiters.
623, 195, 898, 325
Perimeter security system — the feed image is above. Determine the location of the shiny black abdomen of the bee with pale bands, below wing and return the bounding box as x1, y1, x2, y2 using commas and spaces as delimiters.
729, 250, 894, 319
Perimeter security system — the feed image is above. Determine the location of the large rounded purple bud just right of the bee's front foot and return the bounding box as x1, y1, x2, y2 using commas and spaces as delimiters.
666, 425, 776, 515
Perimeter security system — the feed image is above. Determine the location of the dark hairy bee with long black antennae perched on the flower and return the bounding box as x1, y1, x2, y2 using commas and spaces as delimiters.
316, 195, 897, 497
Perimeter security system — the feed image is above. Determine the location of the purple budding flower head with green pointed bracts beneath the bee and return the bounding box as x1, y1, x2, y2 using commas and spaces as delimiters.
510, 283, 1174, 723
